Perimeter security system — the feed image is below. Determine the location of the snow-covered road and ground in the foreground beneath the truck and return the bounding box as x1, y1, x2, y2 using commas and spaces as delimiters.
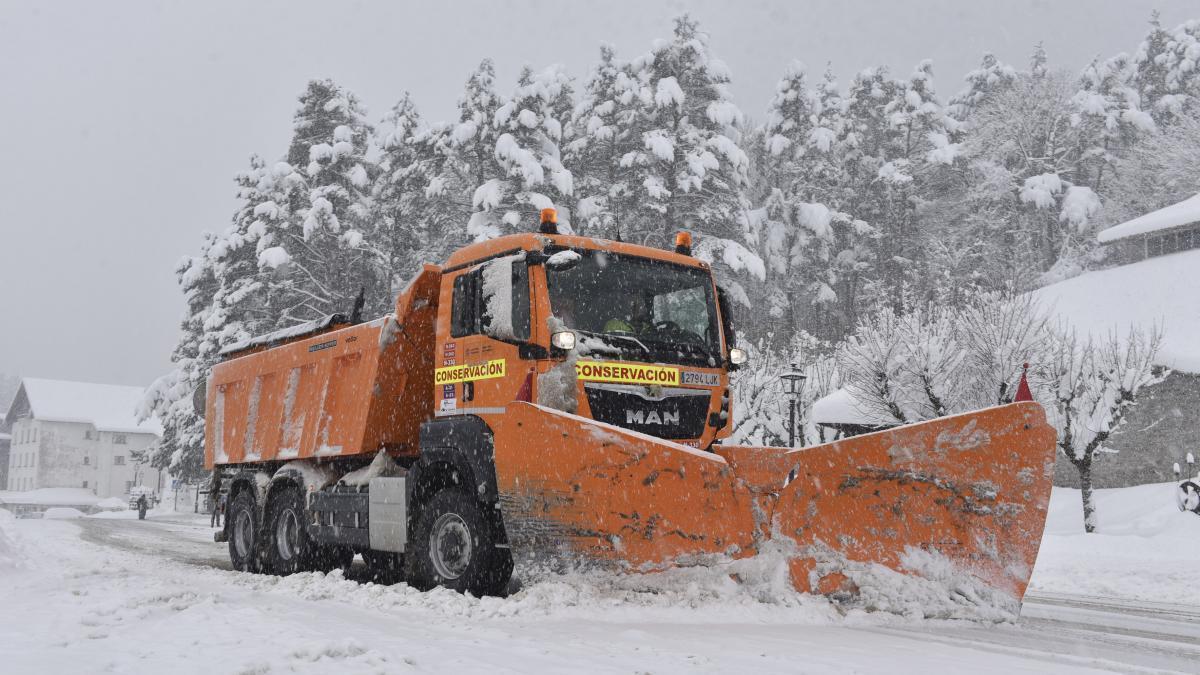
7, 494, 1200, 674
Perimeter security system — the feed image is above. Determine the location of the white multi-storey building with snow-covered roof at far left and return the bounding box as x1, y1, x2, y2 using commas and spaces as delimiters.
5, 377, 162, 498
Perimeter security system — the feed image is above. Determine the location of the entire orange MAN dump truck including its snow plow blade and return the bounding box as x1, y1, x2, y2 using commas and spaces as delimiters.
205, 208, 1055, 604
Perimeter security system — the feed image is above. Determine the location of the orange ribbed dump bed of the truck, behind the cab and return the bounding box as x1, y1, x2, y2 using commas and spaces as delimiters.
204, 265, 440, 468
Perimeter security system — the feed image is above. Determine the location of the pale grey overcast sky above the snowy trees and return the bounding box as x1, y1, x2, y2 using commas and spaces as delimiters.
0, 0, 1200, 384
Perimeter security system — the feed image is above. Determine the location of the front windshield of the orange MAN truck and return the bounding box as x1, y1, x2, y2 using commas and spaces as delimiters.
546, 251, 721, 368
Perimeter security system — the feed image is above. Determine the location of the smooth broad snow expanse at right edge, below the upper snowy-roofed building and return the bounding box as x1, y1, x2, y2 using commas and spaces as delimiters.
1033, 250, 1200, 374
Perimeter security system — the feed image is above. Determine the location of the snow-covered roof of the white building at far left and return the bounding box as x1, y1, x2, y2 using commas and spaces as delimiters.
6, 377, 162, 436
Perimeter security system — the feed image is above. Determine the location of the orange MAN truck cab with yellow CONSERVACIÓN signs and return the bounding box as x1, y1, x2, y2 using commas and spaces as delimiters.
433, 228, 745, 449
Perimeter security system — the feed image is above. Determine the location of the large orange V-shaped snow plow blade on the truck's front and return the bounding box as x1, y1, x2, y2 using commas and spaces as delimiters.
494, 402, 1055, 609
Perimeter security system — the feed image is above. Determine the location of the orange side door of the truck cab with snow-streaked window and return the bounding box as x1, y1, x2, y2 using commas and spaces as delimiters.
434, 255, 533, 417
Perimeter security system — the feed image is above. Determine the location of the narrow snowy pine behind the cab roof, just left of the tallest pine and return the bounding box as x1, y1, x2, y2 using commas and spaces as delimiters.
564, 44, 643, 238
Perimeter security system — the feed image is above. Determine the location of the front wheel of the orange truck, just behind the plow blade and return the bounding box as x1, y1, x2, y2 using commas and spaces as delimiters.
406, 488, 512, 596
